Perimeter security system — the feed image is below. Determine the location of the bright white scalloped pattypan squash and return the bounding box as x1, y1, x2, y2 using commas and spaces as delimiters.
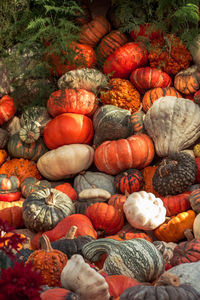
123, 191, 166, 230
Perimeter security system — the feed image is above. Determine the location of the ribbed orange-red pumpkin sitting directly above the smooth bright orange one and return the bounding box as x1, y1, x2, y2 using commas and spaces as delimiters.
47, 89, 98, 117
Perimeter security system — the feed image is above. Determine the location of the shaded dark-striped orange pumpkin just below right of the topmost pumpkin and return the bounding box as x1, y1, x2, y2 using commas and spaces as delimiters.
96, 30, 128, 62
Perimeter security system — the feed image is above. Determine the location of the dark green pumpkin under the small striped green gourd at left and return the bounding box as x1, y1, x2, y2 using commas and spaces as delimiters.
7, 133, 48, 161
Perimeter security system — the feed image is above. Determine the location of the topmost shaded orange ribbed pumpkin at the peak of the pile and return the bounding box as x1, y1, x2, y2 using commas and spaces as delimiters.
79, 15, 111, 47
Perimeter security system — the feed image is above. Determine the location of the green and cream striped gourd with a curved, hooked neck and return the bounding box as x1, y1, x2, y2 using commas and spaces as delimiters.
82, 239, 164, 282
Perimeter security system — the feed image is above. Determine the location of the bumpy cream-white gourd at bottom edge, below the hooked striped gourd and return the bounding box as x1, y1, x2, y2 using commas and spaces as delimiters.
60, 254, 110, 300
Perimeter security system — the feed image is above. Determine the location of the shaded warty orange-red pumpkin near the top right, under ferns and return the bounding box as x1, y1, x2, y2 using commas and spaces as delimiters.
148, 34, 192, 75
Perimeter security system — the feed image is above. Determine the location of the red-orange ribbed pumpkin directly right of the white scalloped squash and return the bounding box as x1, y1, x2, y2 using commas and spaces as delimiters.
160, 191, 191, 217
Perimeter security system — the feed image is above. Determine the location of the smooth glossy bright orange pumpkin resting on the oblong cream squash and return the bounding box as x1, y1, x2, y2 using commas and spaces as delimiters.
43, 113, 94, 149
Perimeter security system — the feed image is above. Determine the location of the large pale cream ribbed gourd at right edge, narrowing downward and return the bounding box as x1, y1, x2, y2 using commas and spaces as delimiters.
144, 96, 200, 157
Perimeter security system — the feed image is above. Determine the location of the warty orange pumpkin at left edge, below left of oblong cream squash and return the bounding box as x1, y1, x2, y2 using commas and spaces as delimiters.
0, 158, 42, 183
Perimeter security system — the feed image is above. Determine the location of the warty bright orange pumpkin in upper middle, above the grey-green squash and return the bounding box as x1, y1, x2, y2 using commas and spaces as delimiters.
100, 78, 141, 113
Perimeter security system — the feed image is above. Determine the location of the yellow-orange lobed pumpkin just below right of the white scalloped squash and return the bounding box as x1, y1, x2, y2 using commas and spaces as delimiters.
154, 210, 196, 242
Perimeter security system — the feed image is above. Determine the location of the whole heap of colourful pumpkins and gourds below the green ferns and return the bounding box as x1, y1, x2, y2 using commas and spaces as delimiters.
0, 7, 200, 300
